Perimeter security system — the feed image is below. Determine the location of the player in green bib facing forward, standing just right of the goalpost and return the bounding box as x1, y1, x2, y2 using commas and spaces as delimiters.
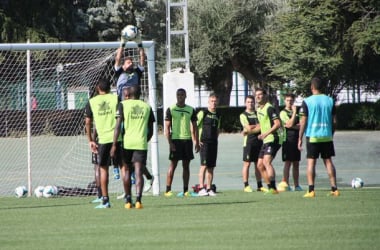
165, 88, 199, 197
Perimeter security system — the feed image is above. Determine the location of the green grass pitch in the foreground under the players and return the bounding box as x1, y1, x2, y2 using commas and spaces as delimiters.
0, 188, 380, 250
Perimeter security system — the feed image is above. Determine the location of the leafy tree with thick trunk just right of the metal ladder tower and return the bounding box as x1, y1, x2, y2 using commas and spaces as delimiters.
189, 0, 275, 105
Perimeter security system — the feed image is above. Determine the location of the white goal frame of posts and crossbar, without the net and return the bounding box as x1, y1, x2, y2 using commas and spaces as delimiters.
0, 41, 160, 196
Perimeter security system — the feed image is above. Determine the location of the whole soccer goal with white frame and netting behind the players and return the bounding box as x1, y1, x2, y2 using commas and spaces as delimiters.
0, 41, 159, 197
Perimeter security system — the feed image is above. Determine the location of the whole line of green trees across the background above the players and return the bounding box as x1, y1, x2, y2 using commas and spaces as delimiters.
0, 0, 380, 105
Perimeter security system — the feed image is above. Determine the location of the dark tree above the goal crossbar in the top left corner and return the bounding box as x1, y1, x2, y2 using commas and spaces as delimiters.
0, 0, 88, 43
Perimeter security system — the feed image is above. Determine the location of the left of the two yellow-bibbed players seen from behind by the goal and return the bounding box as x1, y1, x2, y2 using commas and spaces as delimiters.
85, 79, 118, 208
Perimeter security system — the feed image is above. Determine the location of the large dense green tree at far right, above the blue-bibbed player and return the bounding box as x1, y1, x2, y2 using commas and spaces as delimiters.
265, 0, 380, 99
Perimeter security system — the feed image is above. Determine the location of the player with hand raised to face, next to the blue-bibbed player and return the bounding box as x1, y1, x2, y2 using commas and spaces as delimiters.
278, 93, 302, 191
